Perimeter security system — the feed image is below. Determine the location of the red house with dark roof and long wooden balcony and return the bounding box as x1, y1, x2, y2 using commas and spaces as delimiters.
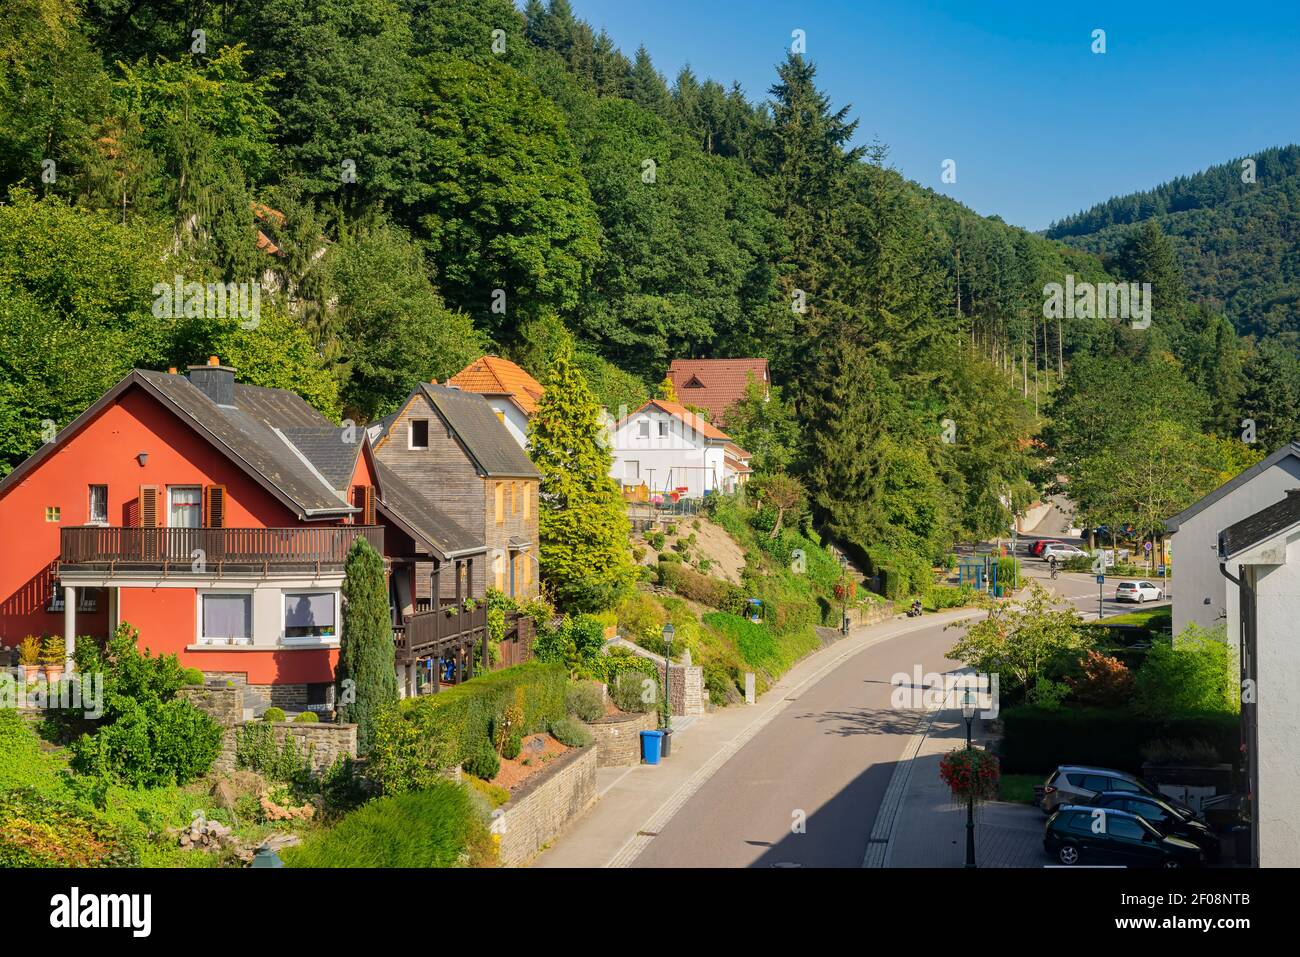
0, 356, 385, 707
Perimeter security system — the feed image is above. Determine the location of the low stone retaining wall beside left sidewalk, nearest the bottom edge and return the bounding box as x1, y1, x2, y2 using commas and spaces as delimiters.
493, 748, 598, 867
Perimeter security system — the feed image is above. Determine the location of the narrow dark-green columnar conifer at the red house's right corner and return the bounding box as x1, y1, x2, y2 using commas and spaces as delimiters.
335, 538, 398, 754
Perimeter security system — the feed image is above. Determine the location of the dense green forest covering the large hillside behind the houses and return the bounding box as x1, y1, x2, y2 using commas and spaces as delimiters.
0, 0, 1279, 583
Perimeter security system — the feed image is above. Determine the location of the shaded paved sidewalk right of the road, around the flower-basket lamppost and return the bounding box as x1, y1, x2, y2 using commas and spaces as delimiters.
862, 686, 1048, 867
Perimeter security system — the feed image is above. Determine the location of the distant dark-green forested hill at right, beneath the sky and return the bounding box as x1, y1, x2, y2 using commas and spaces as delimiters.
1047, 146, 1300, 348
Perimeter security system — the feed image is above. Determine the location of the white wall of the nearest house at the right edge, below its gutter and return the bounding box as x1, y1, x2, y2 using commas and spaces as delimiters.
1256, 553, 1300, 867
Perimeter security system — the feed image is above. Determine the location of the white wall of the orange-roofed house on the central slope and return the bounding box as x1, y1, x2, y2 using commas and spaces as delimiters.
610, 408, 727, 498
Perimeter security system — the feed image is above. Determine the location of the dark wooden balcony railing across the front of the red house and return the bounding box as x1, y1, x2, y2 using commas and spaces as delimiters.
59, 525, 384, 572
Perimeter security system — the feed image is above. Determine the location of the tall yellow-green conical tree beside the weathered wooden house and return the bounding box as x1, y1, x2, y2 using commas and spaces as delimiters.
528, 343, 634, 611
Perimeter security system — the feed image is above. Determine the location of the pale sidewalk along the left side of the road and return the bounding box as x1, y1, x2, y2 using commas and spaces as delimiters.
532, 609, 983, 867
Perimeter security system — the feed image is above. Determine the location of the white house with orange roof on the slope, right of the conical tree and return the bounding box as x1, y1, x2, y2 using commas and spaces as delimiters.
610, 399, 749, 498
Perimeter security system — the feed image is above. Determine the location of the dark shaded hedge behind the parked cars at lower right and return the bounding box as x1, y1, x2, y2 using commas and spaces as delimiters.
998, 705, 1240, 774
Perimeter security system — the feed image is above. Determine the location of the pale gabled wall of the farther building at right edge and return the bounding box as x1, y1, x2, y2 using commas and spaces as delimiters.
1170, 456, 1300, 648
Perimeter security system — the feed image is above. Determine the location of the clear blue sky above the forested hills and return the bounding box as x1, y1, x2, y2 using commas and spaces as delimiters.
571, 0, 1300, 229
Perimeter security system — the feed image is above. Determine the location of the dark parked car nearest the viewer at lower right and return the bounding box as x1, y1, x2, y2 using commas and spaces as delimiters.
1043, 804, 1205, 867
